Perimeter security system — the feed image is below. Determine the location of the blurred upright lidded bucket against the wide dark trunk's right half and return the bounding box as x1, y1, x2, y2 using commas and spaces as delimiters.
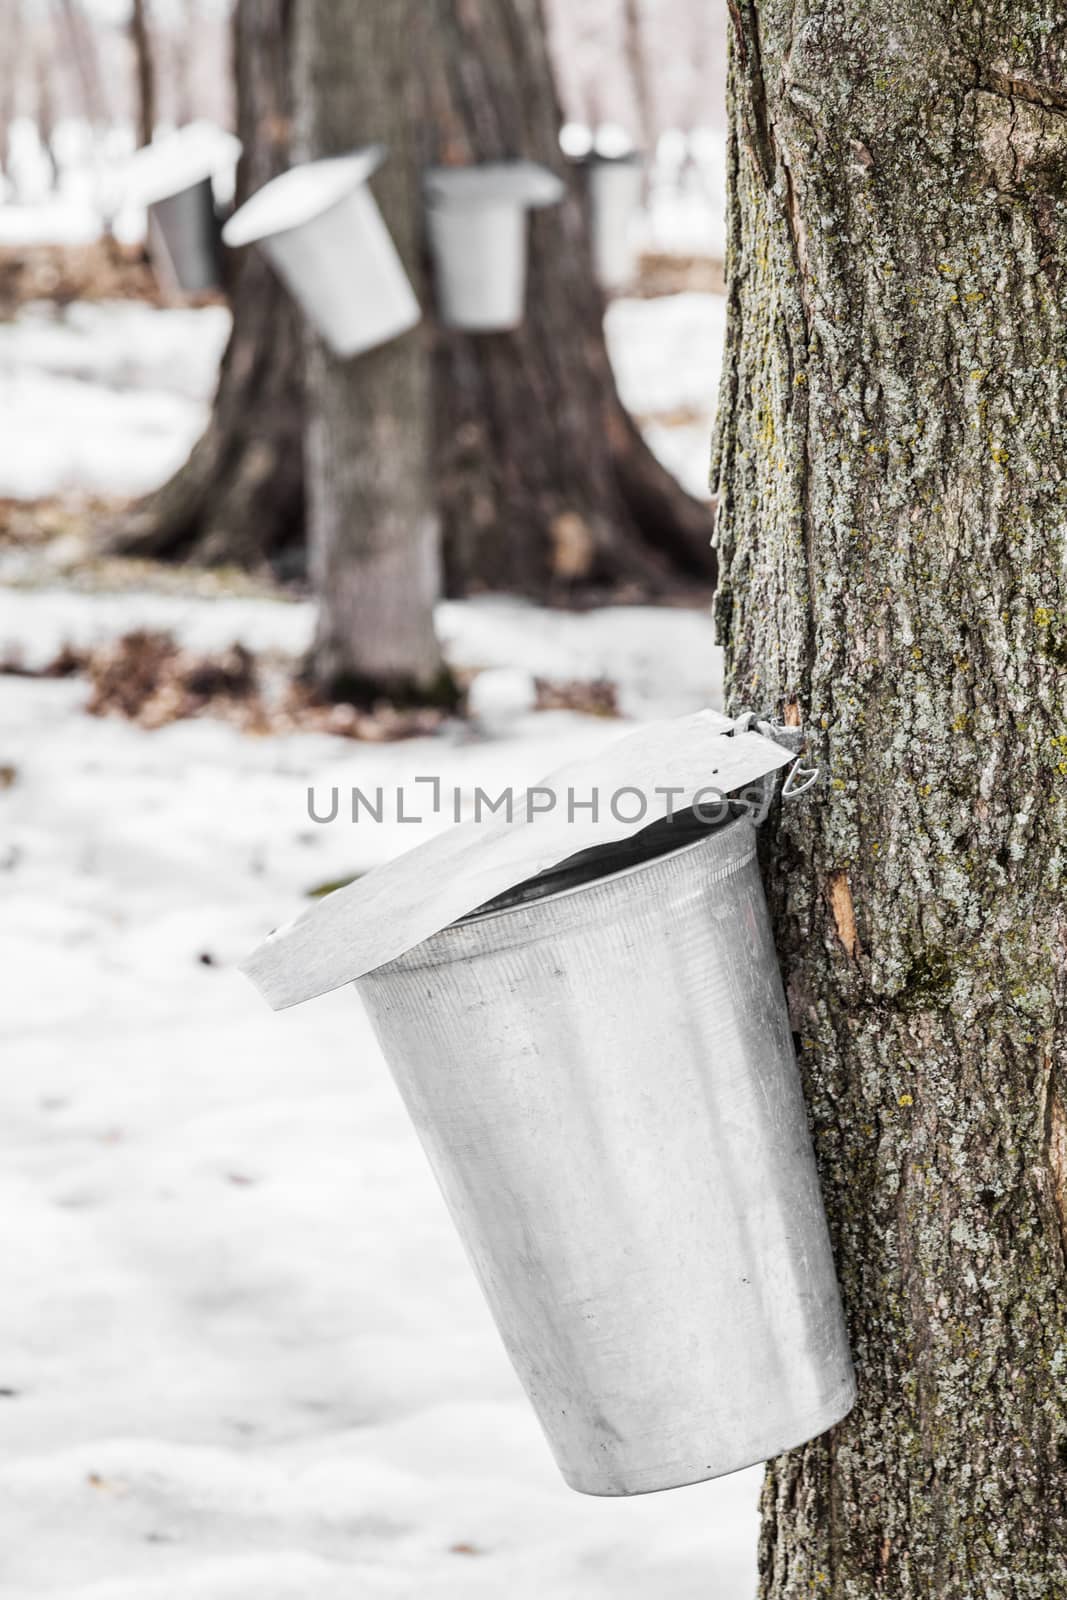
426, 162, 565, 333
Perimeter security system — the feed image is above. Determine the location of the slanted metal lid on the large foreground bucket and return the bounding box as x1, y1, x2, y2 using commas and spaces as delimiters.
242, 710, 793, 1011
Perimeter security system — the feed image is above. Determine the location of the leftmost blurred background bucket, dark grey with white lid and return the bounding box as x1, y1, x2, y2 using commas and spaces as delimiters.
125, 123, 242, 294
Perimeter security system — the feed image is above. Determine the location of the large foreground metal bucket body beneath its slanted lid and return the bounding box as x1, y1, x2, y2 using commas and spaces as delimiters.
357, 819, 854, 1494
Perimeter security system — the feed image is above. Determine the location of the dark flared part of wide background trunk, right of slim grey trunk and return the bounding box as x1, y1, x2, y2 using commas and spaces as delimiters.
424, 0, 713, 595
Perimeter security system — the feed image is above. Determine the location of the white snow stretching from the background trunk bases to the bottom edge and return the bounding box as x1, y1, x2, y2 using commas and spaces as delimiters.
0, 592, 758, 1600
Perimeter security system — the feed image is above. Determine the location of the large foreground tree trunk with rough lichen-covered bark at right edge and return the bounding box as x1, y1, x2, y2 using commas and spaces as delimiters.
717, 0, 1067, 1600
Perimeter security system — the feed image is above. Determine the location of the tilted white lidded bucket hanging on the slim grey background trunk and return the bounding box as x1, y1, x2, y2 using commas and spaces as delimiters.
222, 144, 421, 357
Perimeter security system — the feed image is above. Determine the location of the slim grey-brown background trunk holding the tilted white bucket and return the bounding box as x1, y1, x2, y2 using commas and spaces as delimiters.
294, 0, 446, 698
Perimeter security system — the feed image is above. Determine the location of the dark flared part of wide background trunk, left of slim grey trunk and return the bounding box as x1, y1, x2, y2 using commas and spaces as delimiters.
110, 0, 304, 574
